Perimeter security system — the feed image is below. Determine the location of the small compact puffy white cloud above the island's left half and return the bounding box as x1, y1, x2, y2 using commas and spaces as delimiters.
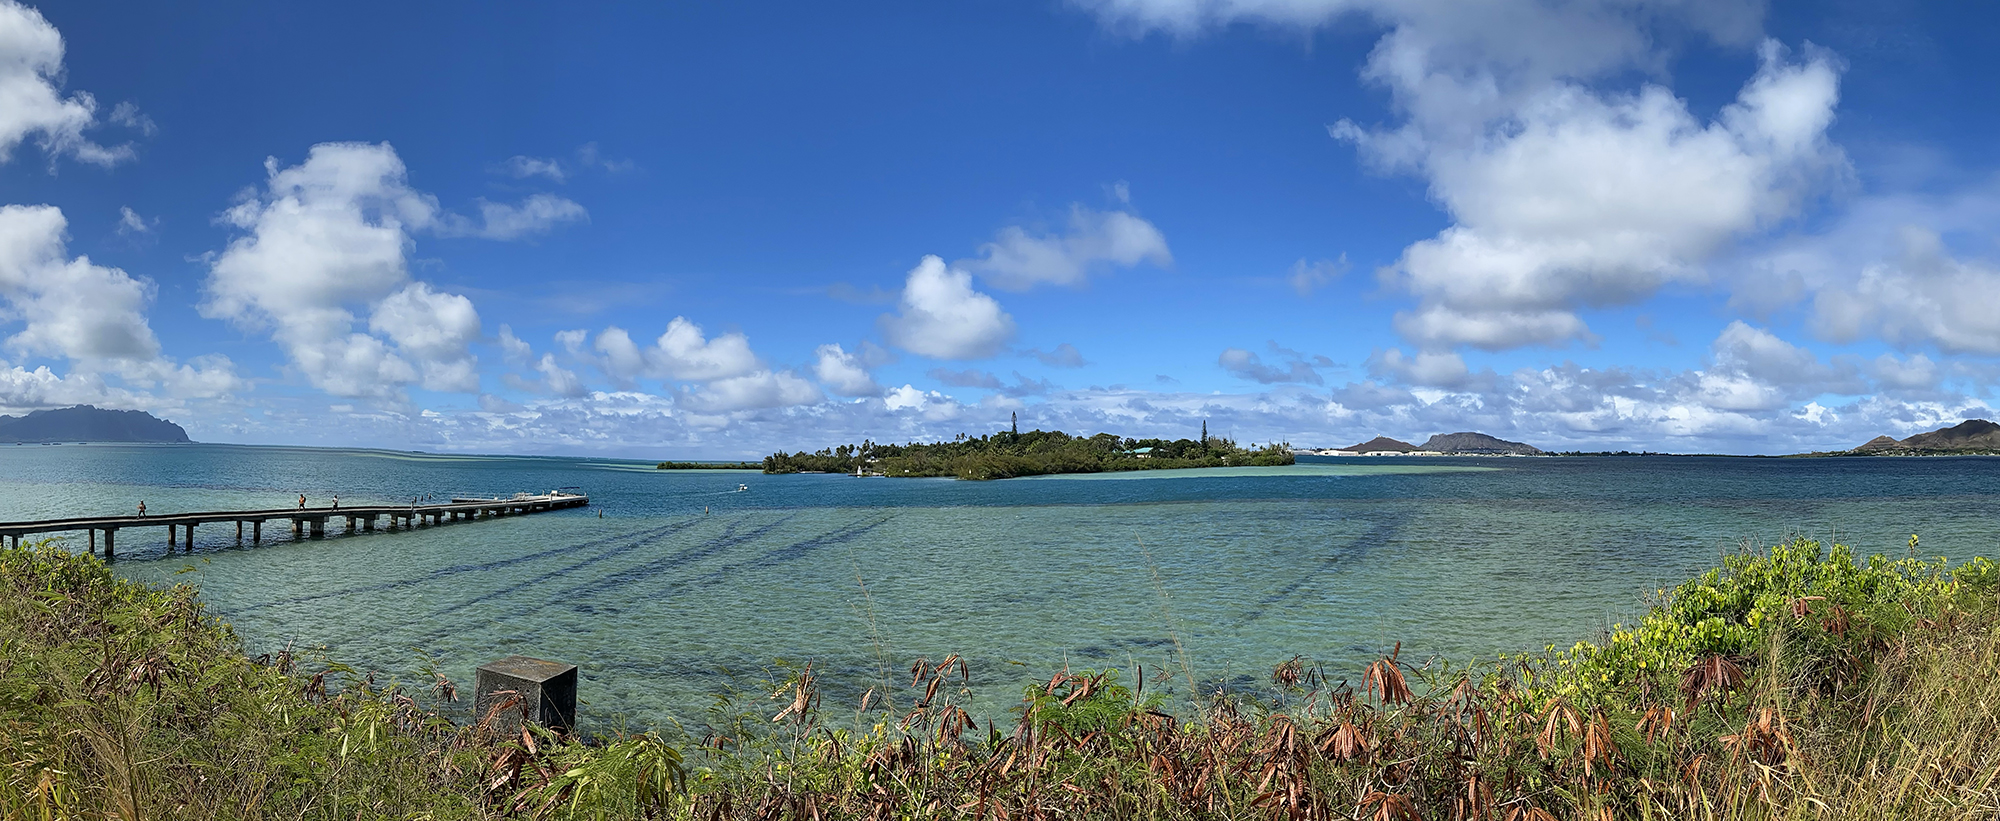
880, 256, 1014, 358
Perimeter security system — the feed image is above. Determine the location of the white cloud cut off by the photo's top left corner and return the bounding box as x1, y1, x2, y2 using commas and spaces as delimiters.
0, 0, 136, 168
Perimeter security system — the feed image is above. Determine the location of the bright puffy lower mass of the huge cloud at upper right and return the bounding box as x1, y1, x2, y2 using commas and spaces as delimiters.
1368, 42, 1844, 348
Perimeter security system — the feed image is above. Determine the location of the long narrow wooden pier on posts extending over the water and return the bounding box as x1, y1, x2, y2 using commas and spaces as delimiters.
0, 491, 590, 559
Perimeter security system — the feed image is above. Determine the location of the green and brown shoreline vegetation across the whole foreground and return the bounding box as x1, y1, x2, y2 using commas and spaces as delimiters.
0, 541, 2000, 821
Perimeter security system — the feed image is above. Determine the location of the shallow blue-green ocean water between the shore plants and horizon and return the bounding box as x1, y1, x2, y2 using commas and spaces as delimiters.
0, 445, 2000, 727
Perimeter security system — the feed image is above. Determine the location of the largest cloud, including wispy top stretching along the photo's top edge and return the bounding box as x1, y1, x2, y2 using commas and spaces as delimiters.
1084, 0, 1846, 350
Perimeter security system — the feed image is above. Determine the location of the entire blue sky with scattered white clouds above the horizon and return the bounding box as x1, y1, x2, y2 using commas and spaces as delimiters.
0, 0, 2000, 459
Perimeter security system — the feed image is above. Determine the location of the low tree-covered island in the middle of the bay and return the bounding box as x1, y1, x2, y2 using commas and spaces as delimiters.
764, 423, 1292, 481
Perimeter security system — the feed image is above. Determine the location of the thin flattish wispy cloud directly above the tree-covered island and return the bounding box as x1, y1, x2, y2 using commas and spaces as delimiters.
960, 204, 1174, 290
